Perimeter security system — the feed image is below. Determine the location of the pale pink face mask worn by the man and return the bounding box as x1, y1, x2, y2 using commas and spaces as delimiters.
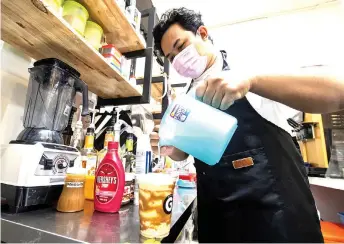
172, 44, 208, 79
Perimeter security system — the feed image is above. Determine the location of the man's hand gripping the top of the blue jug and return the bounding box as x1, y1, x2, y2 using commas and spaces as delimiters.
196, 73, 253, 110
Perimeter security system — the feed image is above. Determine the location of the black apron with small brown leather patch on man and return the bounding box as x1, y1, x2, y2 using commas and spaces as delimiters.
195, 53, 324, 243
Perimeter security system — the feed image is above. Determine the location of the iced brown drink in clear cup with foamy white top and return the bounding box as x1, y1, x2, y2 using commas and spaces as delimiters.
138, 173, 175, 238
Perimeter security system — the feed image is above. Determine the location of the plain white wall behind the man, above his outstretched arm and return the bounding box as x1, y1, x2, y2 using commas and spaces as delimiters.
210, 2, 344, 69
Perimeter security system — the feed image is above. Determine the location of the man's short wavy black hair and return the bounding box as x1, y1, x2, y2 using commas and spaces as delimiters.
153, 8, 204, 56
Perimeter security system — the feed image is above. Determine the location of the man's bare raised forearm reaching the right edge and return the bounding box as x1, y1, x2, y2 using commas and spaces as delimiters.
250, 67, 344, 113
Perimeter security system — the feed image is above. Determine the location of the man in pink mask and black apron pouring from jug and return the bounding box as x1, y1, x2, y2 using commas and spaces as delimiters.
151, 8, 344, 242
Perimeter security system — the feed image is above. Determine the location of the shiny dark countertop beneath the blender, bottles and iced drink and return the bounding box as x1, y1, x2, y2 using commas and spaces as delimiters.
1, 188, 196, 243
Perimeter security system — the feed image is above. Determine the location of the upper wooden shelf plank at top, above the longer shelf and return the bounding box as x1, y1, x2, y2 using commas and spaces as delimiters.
79, 0, 145, 53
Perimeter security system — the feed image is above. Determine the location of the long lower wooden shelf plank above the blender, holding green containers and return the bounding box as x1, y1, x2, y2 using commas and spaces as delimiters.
1, 0, 141, 98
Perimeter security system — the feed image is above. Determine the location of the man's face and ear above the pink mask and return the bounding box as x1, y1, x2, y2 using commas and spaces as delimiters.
161, 24, 214, 63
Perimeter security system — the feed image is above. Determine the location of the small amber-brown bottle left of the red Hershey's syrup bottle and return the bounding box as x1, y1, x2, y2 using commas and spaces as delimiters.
57, 170, 85, 213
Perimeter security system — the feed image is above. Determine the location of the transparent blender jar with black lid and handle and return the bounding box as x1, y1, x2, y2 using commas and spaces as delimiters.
17, 59, 88, 144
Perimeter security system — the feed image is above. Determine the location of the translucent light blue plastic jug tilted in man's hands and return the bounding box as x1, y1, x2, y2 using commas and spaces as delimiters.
159, 89, 238, 165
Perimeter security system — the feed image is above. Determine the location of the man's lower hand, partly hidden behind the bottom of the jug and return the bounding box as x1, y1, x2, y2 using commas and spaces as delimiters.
150, 125, 188, 161
